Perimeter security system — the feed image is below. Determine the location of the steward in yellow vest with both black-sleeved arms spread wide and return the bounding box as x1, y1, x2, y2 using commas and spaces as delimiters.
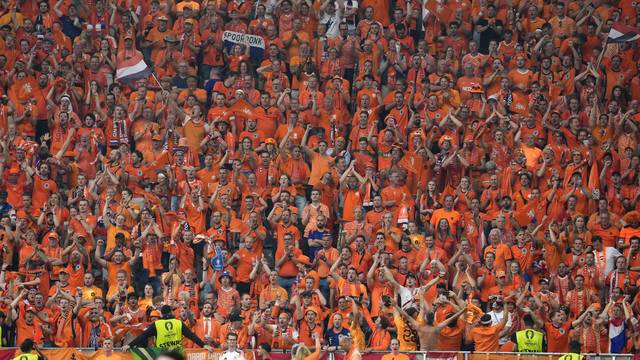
123, 305, 211, 351
